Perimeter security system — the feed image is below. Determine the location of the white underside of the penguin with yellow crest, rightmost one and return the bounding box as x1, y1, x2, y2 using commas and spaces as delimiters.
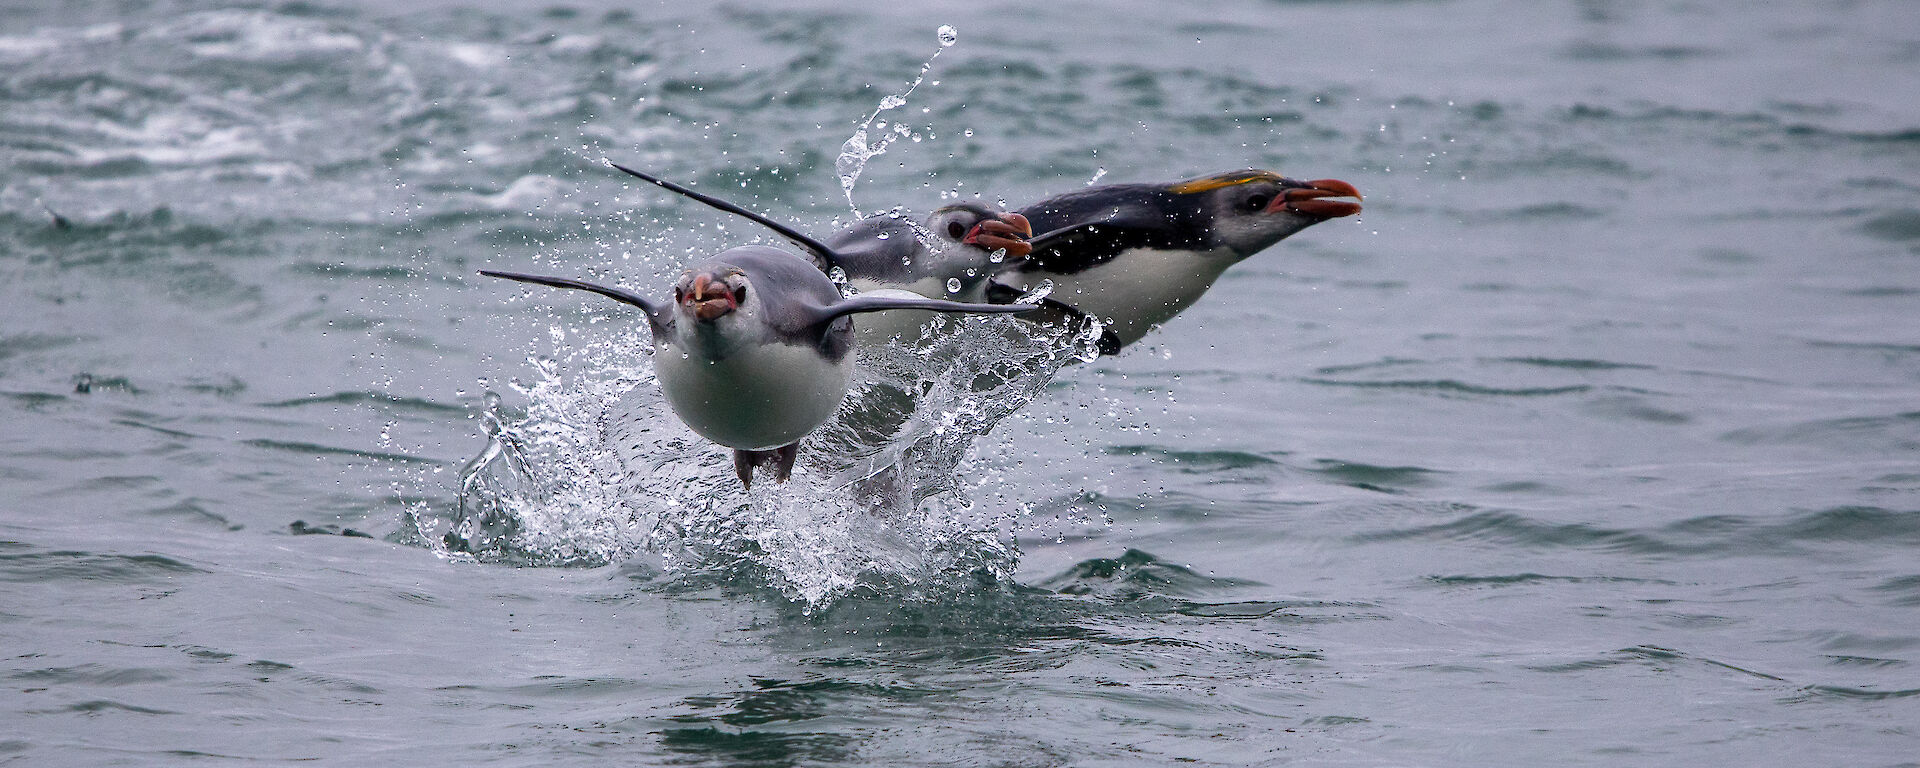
1027, 248, 1238, 344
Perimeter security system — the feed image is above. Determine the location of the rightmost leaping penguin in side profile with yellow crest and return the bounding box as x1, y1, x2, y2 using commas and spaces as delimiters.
991, 169, 1359, 355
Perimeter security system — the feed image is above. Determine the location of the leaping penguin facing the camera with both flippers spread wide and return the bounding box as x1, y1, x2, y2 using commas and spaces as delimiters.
480, 169, 1035, 488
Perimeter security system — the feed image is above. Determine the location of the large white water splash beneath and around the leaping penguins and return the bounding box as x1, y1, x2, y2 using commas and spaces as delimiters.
411, 305, 1100, 609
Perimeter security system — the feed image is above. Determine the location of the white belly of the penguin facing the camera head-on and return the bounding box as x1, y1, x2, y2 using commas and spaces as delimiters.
653, 342, 852, 451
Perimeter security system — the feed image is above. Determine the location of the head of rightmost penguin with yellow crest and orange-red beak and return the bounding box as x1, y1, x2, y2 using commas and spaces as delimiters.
1171, 169, 1361, 257
